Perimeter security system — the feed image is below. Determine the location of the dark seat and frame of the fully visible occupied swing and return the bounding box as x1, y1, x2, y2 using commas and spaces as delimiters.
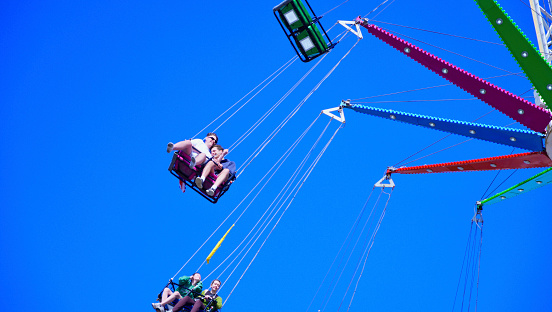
169, 150, 236, 204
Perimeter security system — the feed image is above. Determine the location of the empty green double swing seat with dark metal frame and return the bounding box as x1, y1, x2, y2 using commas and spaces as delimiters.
273, 0, 335, 62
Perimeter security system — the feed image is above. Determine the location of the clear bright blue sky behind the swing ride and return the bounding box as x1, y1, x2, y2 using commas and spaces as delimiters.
0, 0, 552, 312
